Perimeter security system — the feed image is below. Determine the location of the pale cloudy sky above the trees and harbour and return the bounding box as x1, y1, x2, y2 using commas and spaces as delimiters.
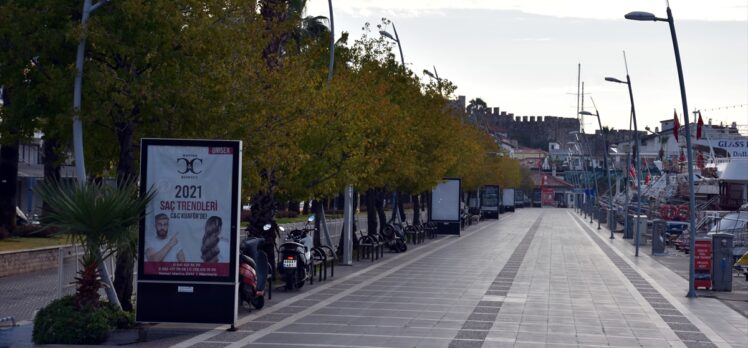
307, 0, 748, 132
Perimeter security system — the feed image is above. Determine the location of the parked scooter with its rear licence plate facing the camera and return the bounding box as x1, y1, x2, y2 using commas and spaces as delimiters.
278, 215, 315, 290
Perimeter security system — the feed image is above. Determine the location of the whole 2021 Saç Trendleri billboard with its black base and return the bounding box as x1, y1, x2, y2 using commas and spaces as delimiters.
136, 139, 242, 324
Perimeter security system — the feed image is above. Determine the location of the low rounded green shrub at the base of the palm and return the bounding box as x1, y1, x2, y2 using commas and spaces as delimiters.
32, 296, 135, 344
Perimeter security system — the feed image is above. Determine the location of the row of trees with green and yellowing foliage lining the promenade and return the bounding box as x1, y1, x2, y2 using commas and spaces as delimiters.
0, 0, 522, 310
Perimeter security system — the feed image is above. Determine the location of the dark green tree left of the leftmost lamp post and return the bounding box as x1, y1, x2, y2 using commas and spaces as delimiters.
0, 0, 80, 238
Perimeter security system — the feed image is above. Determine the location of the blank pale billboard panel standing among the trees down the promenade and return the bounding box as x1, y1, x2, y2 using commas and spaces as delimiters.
429, 178, 462, 235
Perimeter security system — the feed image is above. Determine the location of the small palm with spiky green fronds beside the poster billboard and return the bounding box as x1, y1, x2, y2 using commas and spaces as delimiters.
37, 181, 155, 307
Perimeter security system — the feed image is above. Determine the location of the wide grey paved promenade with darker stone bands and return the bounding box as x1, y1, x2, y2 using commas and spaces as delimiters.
2, 208, 748, 348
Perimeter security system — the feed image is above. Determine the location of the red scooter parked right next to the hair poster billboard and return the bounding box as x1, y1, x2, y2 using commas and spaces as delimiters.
239, 234, 272, 309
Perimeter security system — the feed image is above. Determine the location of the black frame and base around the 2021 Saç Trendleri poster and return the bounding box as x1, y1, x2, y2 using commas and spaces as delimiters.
136, 138, 242, 326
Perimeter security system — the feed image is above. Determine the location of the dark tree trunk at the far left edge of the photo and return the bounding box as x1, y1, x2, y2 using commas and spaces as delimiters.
0, 142, 19, 239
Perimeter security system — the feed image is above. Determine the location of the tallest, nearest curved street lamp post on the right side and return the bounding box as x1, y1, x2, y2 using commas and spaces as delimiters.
624, 4, 696, 298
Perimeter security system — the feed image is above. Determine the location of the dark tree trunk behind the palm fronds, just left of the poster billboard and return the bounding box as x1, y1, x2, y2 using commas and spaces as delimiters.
113, 120, 137, 311
